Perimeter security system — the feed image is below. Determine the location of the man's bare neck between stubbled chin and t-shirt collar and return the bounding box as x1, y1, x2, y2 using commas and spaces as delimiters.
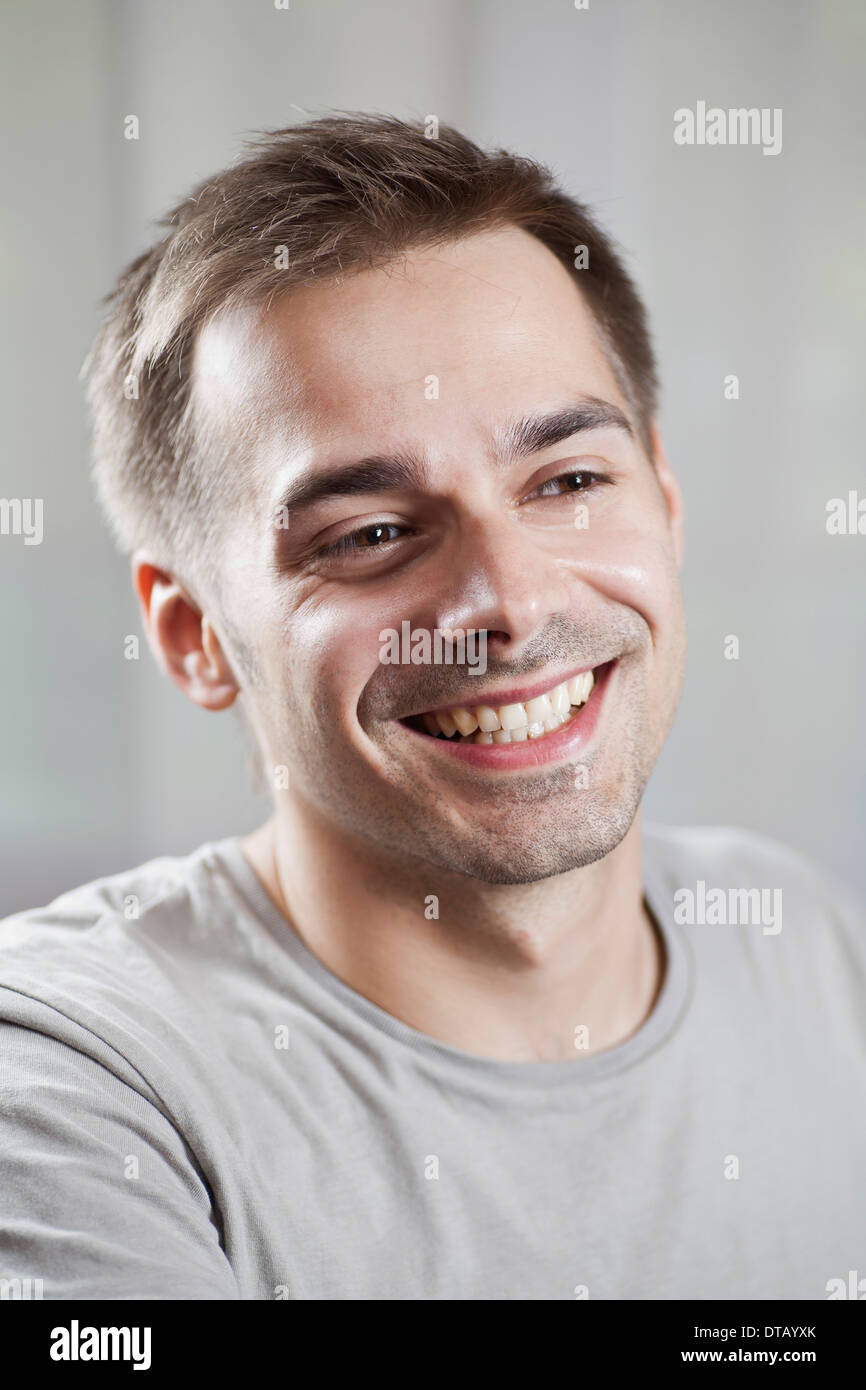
242, 803, 663, 1061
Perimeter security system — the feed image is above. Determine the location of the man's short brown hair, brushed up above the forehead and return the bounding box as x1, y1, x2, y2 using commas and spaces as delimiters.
83, 111, 657, 597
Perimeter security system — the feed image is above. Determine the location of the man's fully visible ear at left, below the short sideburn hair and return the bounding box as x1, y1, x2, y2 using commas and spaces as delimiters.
132, 550, 239, 709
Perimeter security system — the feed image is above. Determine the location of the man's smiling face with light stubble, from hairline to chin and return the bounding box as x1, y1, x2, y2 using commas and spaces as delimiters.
195, 228, 685, 883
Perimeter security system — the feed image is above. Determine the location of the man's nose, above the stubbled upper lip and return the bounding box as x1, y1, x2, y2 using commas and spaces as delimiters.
436, 514, 569, 656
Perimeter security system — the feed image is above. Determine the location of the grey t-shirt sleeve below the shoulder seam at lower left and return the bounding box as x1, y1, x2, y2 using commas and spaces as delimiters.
0, 1022, 240, 1300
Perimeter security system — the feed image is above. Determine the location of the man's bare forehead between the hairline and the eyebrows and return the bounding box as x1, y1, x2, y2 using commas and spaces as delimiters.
193, 227, 631, 483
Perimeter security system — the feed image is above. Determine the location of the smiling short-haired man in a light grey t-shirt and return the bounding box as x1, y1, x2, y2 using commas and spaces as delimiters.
0, 115, 866, 1300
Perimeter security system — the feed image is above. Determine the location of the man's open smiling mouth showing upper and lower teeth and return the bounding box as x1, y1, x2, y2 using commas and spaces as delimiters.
400, 662, 616, 762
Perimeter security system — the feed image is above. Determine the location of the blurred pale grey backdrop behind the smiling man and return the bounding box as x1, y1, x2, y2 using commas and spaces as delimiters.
0, 0, 866, 915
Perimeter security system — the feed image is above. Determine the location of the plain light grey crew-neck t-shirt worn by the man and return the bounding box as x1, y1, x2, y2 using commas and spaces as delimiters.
0, 827, 866, 1300
